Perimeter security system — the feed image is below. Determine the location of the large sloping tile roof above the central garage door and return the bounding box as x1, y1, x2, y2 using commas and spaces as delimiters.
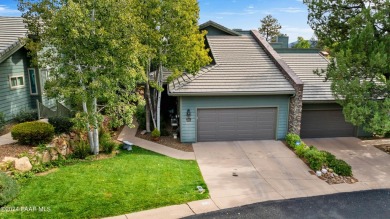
169, 35, 294, 96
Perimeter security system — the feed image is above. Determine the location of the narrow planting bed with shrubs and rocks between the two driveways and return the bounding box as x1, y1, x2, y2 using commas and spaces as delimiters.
286, 133, 358, 184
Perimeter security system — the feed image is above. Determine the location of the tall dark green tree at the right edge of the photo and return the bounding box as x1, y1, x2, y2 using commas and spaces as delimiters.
304, 0, 390, 135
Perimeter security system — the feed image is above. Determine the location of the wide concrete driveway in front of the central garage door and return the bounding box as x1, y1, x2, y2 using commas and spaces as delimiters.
193, 140, 337, 208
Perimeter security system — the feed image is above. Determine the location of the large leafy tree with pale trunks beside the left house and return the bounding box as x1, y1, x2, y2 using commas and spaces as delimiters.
19, 0, 143, 154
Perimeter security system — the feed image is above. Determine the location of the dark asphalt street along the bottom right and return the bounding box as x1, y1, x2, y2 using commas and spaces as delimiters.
186, 189, 390, 219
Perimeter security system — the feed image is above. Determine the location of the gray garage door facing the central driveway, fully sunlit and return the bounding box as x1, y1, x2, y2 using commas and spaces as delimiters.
197, 108, 277, 142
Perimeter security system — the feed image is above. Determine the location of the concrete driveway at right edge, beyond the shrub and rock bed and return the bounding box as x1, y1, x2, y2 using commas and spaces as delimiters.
303, 137, 390, 191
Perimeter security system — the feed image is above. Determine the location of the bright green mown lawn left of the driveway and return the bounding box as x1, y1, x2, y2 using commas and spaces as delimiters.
0, 147, 208, 218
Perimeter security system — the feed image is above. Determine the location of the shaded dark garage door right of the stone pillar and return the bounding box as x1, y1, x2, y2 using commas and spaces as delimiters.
301, 110, 354, 138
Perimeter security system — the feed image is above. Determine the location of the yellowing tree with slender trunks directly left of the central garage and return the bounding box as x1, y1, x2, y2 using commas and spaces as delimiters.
137, 0, 211, 131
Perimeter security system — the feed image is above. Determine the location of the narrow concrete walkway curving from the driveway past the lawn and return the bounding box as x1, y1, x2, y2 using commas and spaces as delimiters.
117, 124, 195, 160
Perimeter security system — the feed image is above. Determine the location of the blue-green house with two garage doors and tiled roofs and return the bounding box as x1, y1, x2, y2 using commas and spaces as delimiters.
163, 21, 358, 142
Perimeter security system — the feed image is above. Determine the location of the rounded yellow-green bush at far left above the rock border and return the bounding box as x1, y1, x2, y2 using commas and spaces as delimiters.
11, 122, 54, 145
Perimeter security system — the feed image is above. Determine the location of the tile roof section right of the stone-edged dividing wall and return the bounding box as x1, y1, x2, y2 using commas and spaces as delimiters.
279, 53, 335, 102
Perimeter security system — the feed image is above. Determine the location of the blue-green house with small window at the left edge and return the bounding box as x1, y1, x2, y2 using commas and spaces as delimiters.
0, 17, 54, 120
